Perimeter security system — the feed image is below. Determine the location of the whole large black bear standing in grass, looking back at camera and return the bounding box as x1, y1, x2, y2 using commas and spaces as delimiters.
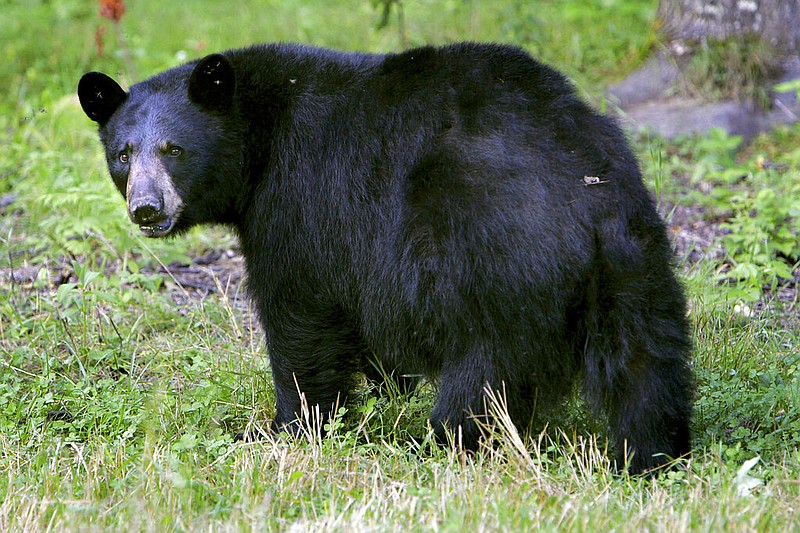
83, 43, 692, 473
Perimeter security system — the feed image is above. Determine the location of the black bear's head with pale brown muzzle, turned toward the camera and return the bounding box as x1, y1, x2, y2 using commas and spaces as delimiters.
78, 54, 243, 237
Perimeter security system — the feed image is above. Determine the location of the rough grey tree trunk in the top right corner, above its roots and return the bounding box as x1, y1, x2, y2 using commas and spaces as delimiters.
657, 0, 800, 55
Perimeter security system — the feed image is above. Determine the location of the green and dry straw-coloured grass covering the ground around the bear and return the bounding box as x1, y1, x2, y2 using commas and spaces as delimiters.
0, 0, 800, 531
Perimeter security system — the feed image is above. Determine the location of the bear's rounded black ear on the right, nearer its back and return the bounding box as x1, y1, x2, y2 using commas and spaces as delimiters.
189, 54, 236, 111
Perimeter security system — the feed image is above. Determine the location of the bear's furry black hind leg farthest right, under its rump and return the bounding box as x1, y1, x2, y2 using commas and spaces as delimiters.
584, 271, 693, 474
